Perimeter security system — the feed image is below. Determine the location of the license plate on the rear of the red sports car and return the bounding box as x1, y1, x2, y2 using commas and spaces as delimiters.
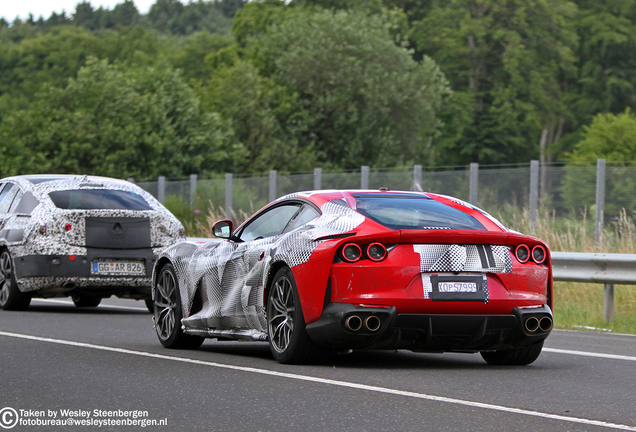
430, 275, 488, 302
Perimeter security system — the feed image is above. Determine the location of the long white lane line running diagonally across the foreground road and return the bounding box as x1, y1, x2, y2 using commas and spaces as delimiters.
0, 331, 636, 432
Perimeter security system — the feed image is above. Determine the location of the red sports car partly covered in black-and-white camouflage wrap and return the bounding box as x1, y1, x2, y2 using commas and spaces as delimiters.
152, 190, 552, 365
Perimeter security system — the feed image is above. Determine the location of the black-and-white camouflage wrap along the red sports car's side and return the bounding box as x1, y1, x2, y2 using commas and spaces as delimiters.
160, 194, 365, 335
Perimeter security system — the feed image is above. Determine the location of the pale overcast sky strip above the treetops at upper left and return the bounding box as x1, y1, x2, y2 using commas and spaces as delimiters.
0, 0, 156, 22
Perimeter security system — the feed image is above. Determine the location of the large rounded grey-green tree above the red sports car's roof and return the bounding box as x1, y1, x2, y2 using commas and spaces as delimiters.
258, 8, 449, 168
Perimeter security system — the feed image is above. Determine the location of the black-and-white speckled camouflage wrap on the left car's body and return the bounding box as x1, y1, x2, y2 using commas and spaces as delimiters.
0, 175, 185, 292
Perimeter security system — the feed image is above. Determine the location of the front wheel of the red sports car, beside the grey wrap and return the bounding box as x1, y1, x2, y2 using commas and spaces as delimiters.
153, 264, 204, 349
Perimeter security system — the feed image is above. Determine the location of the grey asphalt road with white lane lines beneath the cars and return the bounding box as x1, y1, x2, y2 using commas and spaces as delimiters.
0, 299, 636, 432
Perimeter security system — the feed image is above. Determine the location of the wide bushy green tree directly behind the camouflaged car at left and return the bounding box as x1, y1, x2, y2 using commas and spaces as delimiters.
0, 59, 243, 178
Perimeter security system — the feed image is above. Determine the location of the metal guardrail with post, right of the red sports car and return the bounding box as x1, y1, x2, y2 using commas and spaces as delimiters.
551, 252, 636, 321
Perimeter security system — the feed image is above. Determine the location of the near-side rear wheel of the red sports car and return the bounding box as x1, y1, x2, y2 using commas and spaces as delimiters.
267, 267, 321, 364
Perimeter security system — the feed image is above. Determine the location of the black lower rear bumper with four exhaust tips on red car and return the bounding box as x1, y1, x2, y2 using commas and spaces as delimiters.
307, 303, 552, 352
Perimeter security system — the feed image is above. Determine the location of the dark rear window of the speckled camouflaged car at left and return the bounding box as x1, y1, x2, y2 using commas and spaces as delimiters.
49, 189, 152, 210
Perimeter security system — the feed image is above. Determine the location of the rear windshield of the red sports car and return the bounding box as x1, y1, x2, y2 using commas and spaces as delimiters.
353, 194, 486, 231
